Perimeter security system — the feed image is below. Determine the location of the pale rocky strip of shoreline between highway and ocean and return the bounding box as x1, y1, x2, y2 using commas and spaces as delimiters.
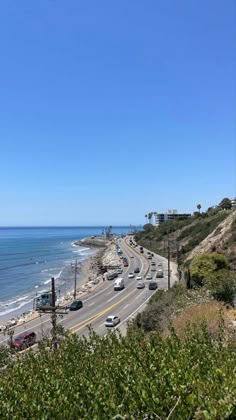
0, 238, 119, 333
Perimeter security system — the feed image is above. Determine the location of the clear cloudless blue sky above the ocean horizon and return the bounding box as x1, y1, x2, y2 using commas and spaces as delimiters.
0, 0, 236, 226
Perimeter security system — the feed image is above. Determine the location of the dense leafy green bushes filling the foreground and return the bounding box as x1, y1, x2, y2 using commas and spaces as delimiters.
0, 325, 236, 419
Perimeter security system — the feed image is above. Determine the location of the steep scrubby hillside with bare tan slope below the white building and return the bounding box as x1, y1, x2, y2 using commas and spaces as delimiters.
136, 209, 236, 270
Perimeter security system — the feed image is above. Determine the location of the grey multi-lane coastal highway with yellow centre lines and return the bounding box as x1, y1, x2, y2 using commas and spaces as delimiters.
0, 238, 173, 344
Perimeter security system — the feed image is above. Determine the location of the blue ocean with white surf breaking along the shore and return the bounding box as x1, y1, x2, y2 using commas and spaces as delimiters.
0, 227, 134, 322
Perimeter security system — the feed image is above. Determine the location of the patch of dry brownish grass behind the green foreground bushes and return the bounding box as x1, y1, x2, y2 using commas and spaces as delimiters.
164, 300, 231, 337
